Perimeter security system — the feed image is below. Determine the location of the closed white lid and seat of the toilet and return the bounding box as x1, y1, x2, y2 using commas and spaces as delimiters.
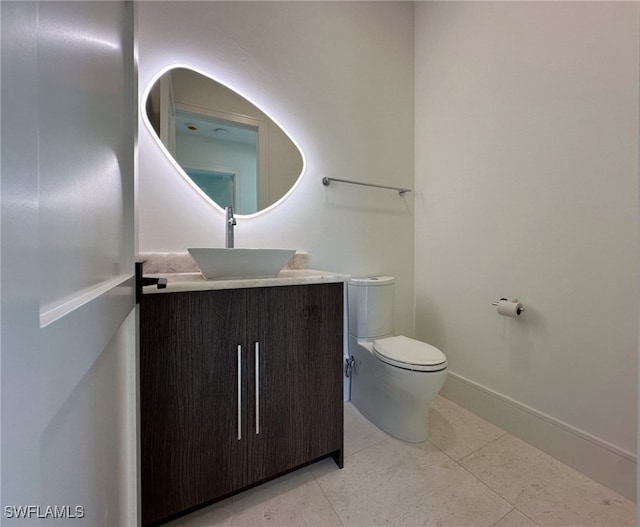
373, 336, 447, 371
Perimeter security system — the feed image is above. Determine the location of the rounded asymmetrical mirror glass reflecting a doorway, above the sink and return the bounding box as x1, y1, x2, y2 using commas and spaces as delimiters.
146, 68, 304, 215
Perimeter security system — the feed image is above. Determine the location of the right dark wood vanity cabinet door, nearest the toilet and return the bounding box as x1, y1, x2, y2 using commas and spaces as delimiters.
247, 283, 343, 481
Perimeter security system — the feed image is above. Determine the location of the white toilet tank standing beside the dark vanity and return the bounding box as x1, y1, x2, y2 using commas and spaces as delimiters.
347, 276, 395, 338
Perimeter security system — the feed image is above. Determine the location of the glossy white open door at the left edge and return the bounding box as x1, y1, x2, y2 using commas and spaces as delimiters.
0, 1, 137, 527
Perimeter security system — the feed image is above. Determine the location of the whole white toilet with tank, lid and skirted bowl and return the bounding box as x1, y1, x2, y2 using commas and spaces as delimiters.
347, 276, 447, 443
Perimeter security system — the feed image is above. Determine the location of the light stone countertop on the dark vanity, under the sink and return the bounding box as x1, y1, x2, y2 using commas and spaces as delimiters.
142, 269, 350, 294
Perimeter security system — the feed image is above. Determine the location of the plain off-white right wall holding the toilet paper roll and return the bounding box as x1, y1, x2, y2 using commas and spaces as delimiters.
415, 2, 640, 496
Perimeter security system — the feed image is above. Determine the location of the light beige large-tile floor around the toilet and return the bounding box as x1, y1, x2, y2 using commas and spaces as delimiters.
167, 396, 635, 527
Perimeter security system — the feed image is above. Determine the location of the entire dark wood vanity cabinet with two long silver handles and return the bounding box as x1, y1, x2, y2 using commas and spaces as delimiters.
140, 283, 343, 525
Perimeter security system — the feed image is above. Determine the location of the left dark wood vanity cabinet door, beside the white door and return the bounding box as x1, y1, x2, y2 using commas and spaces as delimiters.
140, 290, 247, 525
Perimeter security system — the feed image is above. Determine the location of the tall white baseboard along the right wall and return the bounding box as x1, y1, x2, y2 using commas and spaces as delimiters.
440, 371, 636, 501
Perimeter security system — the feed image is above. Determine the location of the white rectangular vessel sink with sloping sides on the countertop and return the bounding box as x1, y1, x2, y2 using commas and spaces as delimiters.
187, 248, 296, 280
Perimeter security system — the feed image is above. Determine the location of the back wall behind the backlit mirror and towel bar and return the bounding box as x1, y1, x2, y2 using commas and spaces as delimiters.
138, 2, 414, 334
